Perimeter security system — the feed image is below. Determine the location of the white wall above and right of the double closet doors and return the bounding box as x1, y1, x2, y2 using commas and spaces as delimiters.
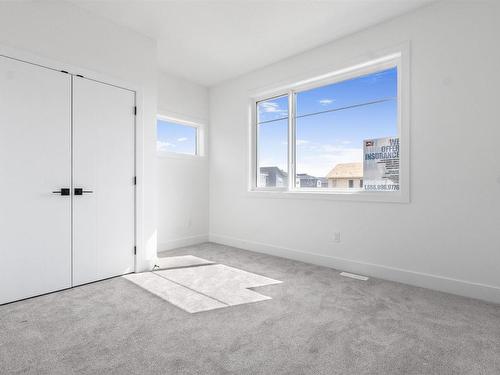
0, 2, 157, 270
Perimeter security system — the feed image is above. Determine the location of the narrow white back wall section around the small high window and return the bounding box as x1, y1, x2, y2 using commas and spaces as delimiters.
158, 73, 208, 251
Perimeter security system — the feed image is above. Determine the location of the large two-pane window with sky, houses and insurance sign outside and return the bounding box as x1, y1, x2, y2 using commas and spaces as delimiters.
253, 54, 401, 200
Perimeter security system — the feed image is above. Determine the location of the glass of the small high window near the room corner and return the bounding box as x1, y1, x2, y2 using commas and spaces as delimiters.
156, 119, 197, 155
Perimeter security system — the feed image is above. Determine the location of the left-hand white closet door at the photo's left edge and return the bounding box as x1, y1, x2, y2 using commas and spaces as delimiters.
0, 56, 71, 304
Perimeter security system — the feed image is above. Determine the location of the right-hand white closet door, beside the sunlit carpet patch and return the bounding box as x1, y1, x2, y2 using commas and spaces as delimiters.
73, 77, 135, 285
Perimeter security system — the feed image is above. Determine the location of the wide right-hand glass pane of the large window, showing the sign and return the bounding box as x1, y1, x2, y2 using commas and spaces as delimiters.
295, 68, 399, 191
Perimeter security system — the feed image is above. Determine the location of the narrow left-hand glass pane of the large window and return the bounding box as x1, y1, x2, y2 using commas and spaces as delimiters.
257, 96, 288, 188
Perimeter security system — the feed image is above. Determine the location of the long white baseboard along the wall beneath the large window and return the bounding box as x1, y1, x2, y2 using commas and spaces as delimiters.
209, 234, 500, 303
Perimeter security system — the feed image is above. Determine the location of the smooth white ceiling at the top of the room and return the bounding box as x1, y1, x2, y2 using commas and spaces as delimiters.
71, 0, 433, 86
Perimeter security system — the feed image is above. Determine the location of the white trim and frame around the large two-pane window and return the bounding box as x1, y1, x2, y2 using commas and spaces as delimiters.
247, 49, 410, 203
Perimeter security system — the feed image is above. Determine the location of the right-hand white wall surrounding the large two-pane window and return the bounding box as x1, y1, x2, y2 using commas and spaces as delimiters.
210, 1, 500, 302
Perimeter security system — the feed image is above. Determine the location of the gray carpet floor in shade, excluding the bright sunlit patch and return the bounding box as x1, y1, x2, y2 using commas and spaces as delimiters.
0, 244, 500, 375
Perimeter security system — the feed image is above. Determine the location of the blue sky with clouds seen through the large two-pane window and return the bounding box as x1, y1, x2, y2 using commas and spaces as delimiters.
257, 68, 398, 177
